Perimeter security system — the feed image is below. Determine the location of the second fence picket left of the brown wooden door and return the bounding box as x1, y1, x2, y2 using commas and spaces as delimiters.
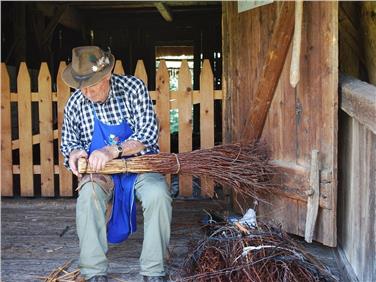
177, 60, 193, 196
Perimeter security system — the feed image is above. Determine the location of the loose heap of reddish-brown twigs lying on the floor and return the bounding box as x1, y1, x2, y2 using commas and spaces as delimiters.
171, 223, 337, 282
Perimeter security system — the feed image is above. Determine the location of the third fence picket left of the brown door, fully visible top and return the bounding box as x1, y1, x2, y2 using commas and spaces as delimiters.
155, 60, 171, 153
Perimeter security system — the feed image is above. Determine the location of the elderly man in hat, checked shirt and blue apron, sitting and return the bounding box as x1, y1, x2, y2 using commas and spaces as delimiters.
61, 46, 171, 281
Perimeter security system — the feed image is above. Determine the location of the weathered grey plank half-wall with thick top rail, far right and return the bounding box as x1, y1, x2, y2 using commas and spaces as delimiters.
338, 77, 376, 281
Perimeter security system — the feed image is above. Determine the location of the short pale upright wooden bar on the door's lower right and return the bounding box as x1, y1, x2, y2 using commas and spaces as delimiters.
304, 150, 320, 243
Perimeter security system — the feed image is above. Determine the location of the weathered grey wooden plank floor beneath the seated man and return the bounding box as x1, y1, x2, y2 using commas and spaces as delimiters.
1, 199, 343, 282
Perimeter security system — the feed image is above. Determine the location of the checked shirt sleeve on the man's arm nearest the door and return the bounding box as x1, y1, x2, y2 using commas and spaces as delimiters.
128, 80, 158, 147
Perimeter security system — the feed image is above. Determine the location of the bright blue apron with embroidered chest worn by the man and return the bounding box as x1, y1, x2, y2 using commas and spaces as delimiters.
89, 102, 137, 243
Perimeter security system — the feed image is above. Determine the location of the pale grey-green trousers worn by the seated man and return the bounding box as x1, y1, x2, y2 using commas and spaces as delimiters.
76, 173, 172, 279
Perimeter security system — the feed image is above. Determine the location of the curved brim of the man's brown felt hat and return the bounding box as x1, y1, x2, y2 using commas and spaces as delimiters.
61, 54, 115, 89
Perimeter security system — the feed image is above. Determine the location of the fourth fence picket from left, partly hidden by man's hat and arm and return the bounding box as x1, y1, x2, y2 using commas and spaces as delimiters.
56, 62, 73, 197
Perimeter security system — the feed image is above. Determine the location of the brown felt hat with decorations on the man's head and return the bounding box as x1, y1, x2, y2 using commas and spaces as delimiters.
62, 46, 115, 88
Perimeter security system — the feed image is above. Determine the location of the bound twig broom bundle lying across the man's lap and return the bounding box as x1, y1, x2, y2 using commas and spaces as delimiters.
78, 142, 275, 196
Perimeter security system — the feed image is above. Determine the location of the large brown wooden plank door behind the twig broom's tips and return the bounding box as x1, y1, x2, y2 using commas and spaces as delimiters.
222, 2, 338, 246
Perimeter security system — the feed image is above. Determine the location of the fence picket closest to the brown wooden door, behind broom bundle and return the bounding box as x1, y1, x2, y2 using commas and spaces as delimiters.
200, 60, 214, 197
